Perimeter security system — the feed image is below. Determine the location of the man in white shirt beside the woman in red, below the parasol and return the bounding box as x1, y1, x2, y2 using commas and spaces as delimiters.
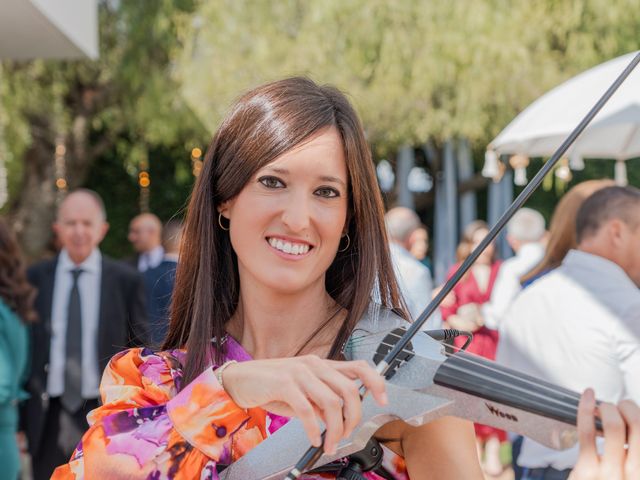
482, 208, 545, 330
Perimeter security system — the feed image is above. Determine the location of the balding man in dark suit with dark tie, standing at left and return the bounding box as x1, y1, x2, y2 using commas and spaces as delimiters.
21, 189, 147, 480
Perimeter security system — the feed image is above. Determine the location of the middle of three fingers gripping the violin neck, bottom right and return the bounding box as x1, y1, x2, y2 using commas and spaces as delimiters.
598, 403, 626, 478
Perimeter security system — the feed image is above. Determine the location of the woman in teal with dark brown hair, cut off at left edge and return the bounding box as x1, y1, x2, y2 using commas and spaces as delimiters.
0, 220, 36, 480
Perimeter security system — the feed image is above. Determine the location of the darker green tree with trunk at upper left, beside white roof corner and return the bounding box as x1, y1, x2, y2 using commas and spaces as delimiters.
0, 0, 204, 255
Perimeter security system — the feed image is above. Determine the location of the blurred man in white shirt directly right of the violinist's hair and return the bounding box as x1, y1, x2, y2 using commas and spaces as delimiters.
384, 207, 442, 328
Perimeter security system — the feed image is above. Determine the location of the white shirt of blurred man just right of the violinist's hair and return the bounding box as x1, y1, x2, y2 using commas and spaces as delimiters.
390, 242, 442, 329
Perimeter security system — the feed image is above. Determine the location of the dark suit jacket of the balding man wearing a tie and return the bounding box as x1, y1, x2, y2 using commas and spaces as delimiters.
21, 255, 148, 455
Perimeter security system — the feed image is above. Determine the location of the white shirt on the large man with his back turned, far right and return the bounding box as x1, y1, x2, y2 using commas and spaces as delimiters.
497, 250, 640, 470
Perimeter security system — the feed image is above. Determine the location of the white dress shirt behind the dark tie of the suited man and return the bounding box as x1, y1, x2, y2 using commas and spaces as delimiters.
47, 249, 102, 398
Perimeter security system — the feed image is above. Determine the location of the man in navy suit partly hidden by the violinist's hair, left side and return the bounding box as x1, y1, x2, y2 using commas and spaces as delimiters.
143, 219, 182, 347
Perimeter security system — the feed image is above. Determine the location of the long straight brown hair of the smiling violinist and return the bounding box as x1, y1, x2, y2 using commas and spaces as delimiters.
163, 77, 401, 384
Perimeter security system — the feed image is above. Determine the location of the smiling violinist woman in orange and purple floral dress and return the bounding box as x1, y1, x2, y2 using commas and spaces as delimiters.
54, 78, 482, 479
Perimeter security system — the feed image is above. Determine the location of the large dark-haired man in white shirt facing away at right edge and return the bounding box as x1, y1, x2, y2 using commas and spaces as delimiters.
497, 187, 640, 480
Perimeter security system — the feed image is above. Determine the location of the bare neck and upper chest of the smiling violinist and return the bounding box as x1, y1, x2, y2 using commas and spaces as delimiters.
227, 282, 344, 359
